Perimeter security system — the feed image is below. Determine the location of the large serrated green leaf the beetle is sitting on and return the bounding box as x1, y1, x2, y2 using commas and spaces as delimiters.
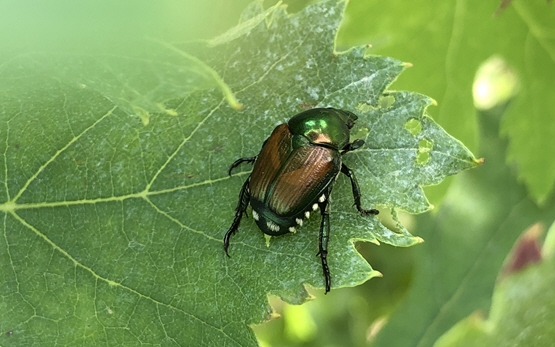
0, 1, 479, 346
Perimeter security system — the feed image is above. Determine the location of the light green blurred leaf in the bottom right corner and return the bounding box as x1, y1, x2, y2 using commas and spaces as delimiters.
434, 224, 555, 347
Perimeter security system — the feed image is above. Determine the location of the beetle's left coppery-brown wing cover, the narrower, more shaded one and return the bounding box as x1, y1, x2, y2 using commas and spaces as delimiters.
249, 124, 293, 202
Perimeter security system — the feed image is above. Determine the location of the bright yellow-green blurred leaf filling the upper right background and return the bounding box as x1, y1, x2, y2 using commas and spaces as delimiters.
338, 0, 555, 204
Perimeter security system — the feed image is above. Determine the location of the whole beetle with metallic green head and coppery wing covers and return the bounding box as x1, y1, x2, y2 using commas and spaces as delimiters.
224, 108, 379, 294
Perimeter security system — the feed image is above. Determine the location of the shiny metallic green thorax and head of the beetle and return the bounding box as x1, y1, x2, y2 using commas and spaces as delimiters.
287, 108, 357, 149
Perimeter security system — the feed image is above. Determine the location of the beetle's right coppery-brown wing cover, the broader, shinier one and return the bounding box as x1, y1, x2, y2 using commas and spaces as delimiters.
267, 146, 341, 216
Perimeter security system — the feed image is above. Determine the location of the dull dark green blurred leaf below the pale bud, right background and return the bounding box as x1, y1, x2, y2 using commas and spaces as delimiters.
373, 108, 555, 346
